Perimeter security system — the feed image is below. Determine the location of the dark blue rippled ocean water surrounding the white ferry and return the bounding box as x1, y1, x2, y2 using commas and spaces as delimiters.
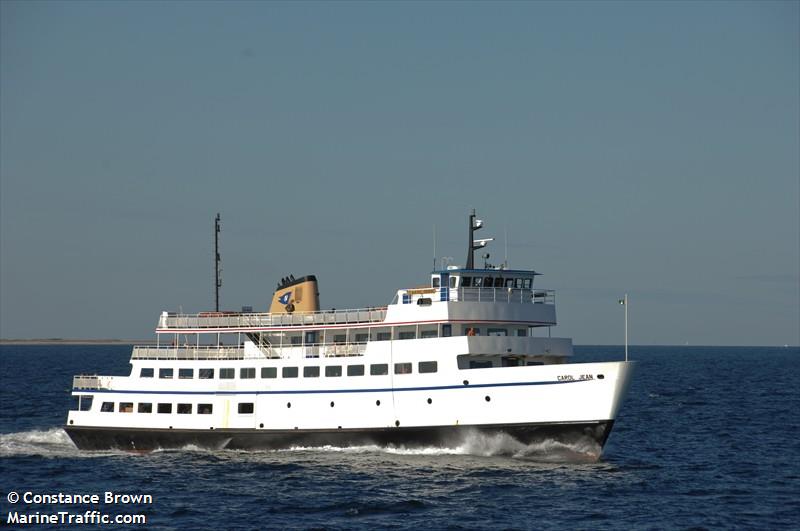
0, 345, 800, 530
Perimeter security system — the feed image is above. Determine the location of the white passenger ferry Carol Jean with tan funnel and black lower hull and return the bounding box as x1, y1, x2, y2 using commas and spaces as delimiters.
65, 211, 632, 455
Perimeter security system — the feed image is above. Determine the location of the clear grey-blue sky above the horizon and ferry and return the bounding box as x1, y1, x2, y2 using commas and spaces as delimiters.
0, 0, 800, 345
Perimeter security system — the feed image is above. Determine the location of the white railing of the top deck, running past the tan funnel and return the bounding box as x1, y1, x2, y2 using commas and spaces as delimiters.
158, 307, 386, 329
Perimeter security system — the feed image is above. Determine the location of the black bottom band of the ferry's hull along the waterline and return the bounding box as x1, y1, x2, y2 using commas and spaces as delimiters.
64, 420, 614, 451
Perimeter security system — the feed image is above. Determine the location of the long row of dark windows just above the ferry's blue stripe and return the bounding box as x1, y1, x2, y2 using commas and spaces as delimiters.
139, 361, 439, 380
